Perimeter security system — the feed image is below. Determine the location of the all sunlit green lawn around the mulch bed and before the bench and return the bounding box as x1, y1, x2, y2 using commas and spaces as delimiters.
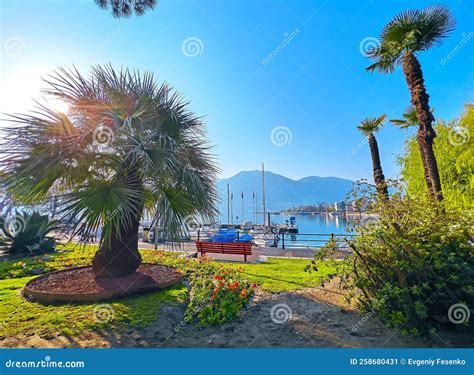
0, 245, 336, 339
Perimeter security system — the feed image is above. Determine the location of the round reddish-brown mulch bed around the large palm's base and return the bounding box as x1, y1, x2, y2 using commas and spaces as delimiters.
23, 263, 182, 303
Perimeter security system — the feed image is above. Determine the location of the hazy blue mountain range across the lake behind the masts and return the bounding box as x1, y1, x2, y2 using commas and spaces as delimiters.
217, 171, 352, 222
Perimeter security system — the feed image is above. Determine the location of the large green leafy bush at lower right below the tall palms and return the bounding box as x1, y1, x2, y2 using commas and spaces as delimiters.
344, 194, 474, 335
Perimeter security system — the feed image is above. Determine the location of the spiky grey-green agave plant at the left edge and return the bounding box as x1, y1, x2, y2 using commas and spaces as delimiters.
0, 212, 57, 255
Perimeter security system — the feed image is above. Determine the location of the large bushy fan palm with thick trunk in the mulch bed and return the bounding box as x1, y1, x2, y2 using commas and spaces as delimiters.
0, 65, 217, 277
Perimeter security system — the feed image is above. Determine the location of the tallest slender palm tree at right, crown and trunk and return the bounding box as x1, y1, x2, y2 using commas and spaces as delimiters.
367, 6, 456, 200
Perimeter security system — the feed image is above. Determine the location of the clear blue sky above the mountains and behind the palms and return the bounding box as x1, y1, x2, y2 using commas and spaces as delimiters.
0, 0, 474, 179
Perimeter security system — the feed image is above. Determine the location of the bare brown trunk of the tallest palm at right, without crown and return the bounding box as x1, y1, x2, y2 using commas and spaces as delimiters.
403, 52, 443, 201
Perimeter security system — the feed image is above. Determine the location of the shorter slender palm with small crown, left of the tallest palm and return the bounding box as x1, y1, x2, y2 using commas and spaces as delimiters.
357, 115, 388, 200
